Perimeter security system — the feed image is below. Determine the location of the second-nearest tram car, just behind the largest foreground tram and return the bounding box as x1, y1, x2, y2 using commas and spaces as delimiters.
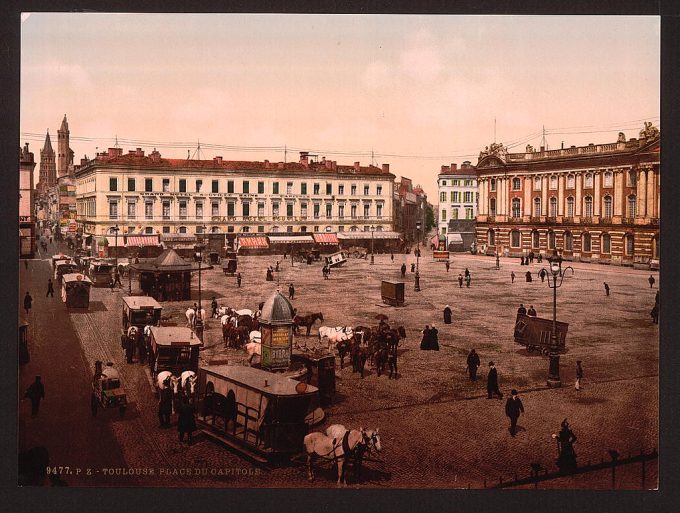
149, 326, 202, 380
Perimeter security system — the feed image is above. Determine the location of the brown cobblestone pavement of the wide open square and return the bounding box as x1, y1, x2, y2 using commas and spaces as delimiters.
17, 242, 659, 488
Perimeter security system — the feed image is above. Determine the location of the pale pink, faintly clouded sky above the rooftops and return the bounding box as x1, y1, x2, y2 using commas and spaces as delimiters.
20, 13, 661, 198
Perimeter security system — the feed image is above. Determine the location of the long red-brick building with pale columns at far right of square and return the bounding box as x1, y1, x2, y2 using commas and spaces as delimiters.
477, 123, 660, 268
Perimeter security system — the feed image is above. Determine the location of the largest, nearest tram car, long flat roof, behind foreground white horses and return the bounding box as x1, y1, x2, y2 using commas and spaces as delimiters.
197, 365, 319, 464
